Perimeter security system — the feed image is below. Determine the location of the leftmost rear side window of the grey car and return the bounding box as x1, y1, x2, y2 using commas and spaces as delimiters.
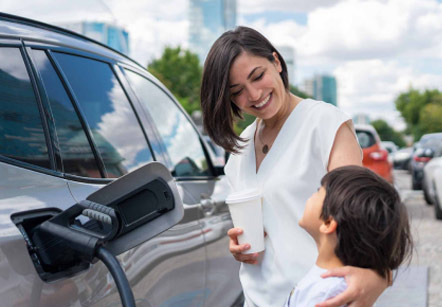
0, 47, 50, 168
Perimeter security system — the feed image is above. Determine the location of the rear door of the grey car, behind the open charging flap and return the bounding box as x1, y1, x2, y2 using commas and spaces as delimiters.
26, 46, 205, 306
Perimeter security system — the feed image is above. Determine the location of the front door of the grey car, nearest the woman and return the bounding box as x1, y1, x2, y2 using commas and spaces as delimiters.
124, 68, 241, 306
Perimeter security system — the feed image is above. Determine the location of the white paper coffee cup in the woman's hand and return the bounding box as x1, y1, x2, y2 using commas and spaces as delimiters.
226, 189, 264, 254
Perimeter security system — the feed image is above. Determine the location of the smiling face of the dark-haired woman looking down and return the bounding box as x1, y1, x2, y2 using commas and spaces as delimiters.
229, 52, 289, 119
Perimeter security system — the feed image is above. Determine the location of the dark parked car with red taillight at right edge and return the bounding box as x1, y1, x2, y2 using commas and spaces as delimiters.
410, 133, 442, 190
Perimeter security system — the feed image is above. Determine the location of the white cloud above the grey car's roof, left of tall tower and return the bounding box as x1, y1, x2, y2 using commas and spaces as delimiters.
0, 0, 189, 66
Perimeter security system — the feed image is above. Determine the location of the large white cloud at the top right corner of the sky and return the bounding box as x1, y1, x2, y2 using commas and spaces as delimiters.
299, 0, 442, 60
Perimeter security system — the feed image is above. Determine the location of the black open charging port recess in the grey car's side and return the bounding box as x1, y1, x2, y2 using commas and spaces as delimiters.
11, 208, 90, 282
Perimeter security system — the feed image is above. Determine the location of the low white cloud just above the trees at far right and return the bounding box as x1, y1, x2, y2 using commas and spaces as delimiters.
334, 59, 442, 130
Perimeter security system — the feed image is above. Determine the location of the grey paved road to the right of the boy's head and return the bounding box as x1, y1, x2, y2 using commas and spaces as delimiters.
394, 170, 442, 307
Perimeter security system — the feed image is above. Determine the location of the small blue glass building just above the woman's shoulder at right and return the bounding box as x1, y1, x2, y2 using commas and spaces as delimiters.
303, 75, 338, 106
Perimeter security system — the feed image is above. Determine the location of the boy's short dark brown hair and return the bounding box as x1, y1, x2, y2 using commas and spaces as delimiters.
321, 166, 413, 279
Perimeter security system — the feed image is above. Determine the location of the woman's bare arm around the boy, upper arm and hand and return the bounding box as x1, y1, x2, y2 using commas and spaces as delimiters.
316, 124, 388, 307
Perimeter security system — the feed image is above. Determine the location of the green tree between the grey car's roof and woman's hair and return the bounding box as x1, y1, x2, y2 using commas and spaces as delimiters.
147, 47, 202, 114
